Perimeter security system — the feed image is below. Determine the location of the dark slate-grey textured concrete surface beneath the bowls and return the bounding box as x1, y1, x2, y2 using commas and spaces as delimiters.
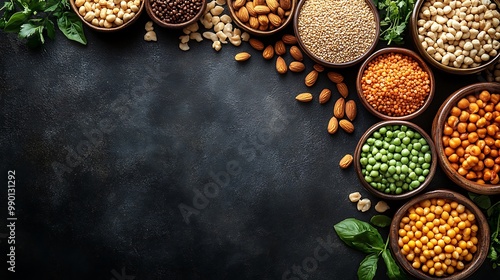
0, 8, 500, 280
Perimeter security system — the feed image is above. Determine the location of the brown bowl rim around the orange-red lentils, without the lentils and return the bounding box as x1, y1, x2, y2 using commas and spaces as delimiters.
356, 47, 436, 121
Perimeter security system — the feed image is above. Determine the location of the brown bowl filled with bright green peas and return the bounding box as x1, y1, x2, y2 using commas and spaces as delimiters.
354, 120, 438, 200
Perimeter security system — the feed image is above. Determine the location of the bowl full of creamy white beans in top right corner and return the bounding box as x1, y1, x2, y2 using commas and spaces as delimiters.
410, 0, 500, 75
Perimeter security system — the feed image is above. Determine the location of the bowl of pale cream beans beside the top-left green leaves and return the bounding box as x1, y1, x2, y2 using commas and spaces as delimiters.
70, 0, 145, 32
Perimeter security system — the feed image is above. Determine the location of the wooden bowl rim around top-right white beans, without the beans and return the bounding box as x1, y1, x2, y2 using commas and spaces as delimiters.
410, 0, 500, 75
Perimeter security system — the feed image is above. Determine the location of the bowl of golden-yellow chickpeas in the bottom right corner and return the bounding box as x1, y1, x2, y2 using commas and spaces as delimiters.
389, 190, 490, 280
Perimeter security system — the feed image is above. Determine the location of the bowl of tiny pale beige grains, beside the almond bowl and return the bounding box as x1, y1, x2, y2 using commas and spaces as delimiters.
293, 0, 380, 68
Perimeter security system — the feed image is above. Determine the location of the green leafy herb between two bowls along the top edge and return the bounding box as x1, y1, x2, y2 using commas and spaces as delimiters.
374, 0, 415, 45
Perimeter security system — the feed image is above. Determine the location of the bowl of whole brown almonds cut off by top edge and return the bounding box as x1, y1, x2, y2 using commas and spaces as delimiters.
227, 0, 297, 36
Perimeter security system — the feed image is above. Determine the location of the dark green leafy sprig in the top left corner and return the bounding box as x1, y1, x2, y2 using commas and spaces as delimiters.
0, 0, 87, 47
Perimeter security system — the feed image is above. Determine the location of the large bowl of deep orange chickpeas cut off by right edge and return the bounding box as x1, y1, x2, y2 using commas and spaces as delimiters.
432, 82, 500, 195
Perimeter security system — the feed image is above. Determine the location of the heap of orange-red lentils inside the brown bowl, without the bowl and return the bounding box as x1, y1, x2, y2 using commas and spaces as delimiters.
361, 53, 430, 117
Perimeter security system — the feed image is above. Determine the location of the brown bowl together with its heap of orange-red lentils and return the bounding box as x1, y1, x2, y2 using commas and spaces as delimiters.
356, 47, 435, 120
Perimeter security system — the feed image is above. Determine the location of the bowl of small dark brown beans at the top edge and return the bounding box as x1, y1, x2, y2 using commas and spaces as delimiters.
143, 0, 207, 29
